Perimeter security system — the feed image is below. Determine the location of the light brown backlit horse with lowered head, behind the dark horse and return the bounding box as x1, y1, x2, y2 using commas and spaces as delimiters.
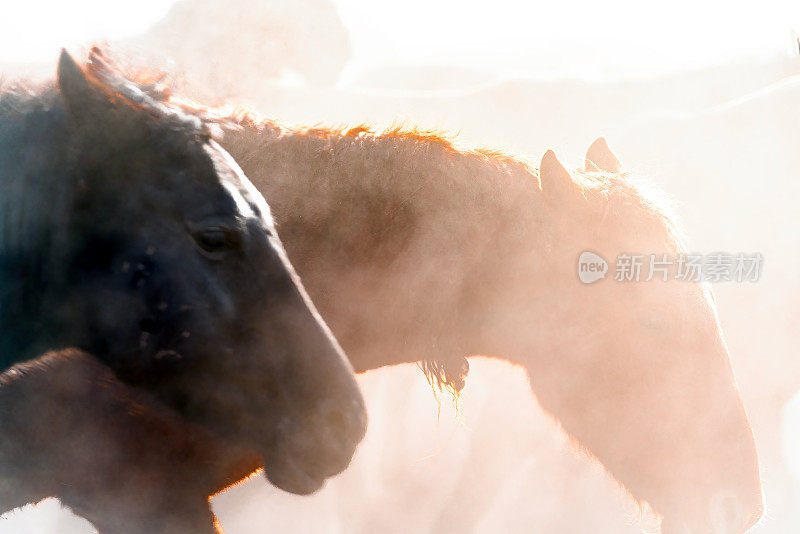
0, 60, 762, 534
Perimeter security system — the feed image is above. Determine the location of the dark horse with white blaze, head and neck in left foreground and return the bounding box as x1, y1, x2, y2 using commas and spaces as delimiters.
0, 50, 366, 531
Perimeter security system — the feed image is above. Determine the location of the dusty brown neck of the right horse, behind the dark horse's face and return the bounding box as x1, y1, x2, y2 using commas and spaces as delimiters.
226, 124, 552, 370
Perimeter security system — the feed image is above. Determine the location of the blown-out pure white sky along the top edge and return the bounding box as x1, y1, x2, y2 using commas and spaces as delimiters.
0, 0, 800, 77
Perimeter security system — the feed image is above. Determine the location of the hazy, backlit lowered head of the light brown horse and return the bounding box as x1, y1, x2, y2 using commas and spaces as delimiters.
526, 138, 762, 534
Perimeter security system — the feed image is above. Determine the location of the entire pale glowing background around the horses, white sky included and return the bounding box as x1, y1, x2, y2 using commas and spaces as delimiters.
0, 0, 800, 534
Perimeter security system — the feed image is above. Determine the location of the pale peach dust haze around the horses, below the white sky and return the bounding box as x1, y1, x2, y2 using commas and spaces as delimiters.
0, 0, 800, 534
